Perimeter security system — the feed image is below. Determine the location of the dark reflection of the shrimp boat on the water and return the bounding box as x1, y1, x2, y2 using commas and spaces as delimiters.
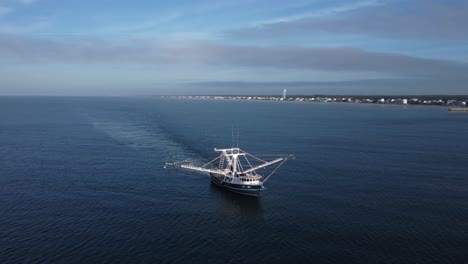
210, 182, 264, 218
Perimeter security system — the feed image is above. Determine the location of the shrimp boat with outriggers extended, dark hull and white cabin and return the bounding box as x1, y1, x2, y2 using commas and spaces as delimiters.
164, 148, 294, 196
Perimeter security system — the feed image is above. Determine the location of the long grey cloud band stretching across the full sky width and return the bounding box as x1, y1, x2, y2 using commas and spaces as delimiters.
0, 34, 468, 79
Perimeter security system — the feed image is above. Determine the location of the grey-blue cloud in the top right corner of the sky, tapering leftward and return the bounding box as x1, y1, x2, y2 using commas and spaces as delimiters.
227, 0, 468, 40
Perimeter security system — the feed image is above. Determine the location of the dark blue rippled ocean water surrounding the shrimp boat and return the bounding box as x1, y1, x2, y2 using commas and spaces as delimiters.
0, 97, 468, 263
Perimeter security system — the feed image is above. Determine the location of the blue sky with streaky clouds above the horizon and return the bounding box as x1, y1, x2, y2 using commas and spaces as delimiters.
0, 0, 468, 95
